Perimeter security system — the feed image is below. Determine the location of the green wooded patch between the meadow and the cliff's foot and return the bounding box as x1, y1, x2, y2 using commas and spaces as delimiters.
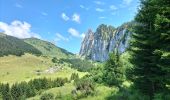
61, 58, 94, 72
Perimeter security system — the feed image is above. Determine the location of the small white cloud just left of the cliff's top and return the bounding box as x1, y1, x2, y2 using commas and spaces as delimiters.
68, 28, 85, 38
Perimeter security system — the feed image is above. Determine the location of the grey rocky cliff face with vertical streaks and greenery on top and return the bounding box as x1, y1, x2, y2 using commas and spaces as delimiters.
79, 24, 131, 62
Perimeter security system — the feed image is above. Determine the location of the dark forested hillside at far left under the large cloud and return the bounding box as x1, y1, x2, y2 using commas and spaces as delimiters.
0, 33, 41, 56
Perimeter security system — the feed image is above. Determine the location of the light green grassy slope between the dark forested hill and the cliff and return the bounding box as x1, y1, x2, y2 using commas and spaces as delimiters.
24, 38, 73, 58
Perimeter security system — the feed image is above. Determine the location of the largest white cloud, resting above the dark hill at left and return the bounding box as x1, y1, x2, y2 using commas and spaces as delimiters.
0, 20, 41, 38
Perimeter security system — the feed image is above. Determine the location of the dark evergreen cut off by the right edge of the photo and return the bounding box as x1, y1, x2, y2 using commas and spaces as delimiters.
154, 0, 170, 93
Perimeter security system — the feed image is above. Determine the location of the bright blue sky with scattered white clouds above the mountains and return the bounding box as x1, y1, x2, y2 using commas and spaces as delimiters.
0, 0, 139, 53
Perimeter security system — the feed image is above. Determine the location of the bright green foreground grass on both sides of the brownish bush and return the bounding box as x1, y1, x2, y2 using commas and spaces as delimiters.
27, 83, 113, 100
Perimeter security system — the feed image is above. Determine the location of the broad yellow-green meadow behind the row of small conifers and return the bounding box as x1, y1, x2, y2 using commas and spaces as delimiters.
0, 54, 86, 84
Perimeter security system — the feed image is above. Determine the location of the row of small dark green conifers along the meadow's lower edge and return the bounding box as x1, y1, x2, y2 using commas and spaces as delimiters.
0, 78, 68, 100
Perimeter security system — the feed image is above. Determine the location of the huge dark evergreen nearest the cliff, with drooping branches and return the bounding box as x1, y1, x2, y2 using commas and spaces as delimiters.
129, 0, 170, 99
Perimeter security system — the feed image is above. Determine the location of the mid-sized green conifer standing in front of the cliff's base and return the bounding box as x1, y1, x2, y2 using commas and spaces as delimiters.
103, 53, 125, 87
